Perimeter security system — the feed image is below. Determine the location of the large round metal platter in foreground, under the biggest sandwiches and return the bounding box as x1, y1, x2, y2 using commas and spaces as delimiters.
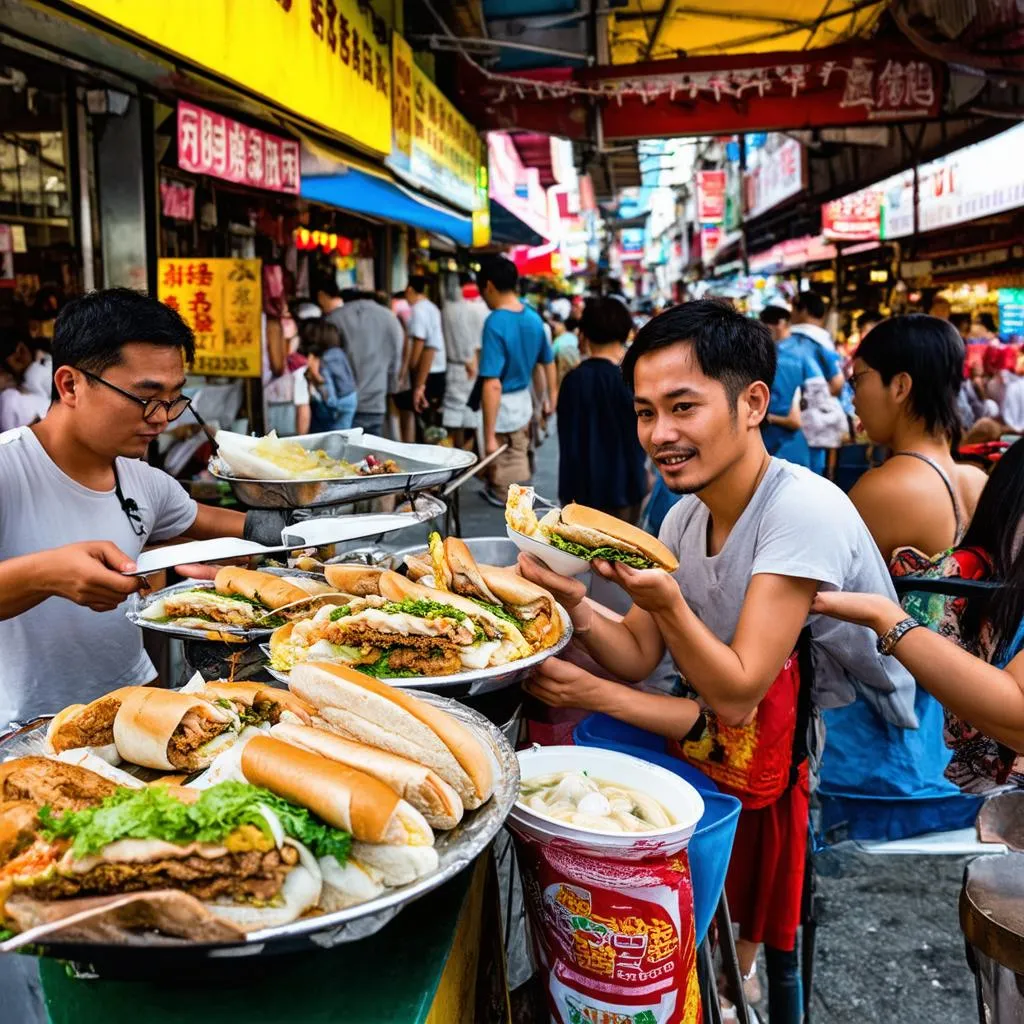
0, 693, 519, 977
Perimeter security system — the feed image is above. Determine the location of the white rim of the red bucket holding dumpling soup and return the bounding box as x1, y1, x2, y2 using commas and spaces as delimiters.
507, 745, 703, 860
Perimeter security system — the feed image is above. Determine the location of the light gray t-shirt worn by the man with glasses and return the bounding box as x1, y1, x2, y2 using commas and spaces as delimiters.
0, 427, 197, 728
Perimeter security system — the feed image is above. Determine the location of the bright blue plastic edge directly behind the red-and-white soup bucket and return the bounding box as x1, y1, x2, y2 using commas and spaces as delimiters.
572, 715, 740, 945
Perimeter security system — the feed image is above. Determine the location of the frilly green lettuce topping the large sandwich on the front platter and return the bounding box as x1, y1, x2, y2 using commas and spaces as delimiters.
39, 781, 350, 863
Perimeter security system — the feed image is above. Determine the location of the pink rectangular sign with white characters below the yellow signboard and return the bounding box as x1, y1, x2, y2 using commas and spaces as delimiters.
178, 102, 299, 194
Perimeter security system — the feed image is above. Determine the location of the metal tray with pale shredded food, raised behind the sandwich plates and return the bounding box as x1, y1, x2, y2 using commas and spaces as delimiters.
209, 430, 476, 509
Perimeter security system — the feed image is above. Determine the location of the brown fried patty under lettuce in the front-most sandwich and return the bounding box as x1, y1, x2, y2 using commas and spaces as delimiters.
29, 846, 298, 903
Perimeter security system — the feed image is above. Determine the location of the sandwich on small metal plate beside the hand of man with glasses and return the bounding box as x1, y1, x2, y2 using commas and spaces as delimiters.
141, 566, 339, 629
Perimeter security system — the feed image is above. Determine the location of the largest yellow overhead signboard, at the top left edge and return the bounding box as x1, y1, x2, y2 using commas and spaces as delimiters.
65, 0, 391, 154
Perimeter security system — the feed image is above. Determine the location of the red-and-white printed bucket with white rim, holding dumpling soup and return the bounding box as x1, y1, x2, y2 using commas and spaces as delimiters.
507, 746, 703, 1024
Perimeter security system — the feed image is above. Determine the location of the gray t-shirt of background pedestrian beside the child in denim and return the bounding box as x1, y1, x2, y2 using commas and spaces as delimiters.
327, 299, 406, 416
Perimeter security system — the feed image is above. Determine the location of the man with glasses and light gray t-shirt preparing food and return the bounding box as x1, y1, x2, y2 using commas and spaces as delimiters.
0, 289, 245, 728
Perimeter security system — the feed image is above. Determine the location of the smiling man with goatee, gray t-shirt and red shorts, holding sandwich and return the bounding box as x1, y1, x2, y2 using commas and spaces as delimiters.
520, 301, 916, 1024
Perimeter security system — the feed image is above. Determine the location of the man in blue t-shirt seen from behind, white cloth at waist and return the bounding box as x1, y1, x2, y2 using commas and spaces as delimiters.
476, 256, 558, 507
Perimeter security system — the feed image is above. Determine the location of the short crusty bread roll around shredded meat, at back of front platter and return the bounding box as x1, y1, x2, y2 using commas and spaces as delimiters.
114, 686, 238, 771
